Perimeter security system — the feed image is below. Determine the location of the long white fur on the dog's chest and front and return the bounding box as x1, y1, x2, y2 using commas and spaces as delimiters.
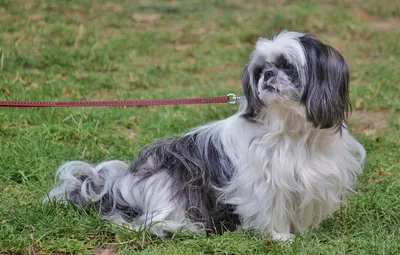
219, 113, 361, 233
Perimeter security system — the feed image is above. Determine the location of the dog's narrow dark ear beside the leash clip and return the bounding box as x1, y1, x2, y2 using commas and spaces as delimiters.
241, 65, 262, 121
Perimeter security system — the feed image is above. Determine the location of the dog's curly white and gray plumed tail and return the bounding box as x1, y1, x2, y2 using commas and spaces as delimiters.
46, 160, 128, 215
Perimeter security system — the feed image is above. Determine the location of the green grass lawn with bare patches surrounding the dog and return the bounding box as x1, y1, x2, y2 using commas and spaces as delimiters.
0, 0, 400, 254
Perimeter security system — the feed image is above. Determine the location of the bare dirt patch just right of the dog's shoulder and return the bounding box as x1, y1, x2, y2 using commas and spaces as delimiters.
350, 110, 389, 136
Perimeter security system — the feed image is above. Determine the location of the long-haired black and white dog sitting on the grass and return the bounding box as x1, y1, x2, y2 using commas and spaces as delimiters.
49, 31, 365, 240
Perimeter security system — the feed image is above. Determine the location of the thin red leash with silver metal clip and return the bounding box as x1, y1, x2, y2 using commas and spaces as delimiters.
0, 94, 240, 107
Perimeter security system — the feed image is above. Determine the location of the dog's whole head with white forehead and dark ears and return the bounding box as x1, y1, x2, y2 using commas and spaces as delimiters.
242, 31, 351, 128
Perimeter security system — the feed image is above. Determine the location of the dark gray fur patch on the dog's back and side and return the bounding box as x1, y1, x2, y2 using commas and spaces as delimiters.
129, 133, 239, 233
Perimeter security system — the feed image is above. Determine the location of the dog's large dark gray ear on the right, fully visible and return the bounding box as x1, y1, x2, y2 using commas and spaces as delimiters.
300, 35, 351, 130
